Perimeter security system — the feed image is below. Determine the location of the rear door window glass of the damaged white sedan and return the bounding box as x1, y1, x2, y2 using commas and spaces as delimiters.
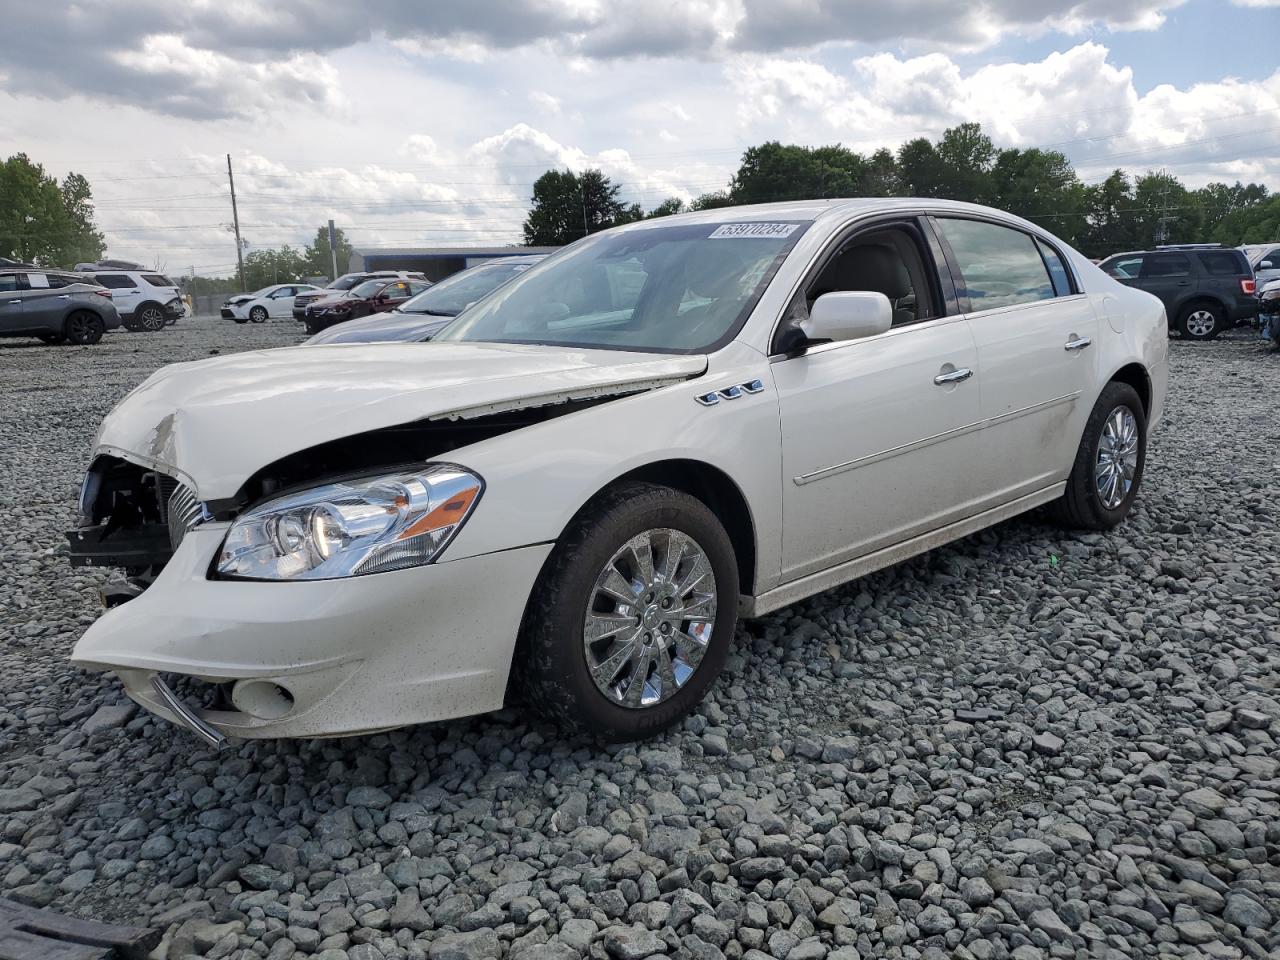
938, 218, 1055, 312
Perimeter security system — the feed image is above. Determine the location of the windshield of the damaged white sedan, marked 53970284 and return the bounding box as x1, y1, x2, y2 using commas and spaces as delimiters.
436, 221, 808, 353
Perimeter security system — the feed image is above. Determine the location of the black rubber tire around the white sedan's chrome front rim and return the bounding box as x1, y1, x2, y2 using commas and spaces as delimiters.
513, 483, 739, 742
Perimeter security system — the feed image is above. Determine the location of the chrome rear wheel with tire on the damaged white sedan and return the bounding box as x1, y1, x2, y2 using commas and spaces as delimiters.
1052, 381, 1147, 530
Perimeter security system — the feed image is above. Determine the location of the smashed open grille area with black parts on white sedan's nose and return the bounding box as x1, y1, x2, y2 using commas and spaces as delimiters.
67, 454, 209, 607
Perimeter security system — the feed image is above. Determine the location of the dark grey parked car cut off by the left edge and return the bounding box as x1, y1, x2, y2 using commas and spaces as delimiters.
0, 268, 120, 344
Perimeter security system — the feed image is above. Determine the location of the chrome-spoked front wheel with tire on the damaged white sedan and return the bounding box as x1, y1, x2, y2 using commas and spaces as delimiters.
516, 483, 739, 742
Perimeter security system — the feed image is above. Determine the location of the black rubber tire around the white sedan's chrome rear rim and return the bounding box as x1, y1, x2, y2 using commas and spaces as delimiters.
1050, 380, 1147, 530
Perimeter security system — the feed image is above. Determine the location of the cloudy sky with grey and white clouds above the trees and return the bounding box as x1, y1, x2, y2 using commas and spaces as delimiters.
0, 0, 1280, 275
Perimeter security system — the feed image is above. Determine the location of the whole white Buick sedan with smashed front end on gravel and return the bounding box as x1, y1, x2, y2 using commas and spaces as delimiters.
69, 200, 1167, 742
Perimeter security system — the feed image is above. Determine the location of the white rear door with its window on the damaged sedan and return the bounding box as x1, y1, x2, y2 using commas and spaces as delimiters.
936, 216, 1098, 507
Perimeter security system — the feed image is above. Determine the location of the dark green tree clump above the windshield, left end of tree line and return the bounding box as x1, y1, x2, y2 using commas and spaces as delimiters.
525, 170, 627, 247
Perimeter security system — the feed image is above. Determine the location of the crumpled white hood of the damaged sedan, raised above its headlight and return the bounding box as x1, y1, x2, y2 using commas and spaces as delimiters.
95, 343, 707, 500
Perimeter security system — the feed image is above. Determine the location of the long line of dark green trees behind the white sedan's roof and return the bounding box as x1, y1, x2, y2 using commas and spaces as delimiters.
524, 123, 1280, 257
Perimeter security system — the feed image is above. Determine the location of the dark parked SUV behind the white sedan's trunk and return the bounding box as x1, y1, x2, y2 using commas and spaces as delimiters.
1098, 243, 1258, 340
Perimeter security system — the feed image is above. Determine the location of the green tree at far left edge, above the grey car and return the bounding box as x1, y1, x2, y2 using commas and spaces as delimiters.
0, 154, 104, 268
